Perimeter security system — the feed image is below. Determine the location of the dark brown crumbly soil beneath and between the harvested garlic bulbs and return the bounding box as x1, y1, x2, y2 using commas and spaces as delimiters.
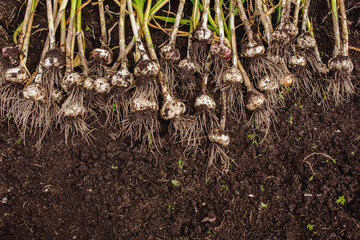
0, 0, 360, 239
